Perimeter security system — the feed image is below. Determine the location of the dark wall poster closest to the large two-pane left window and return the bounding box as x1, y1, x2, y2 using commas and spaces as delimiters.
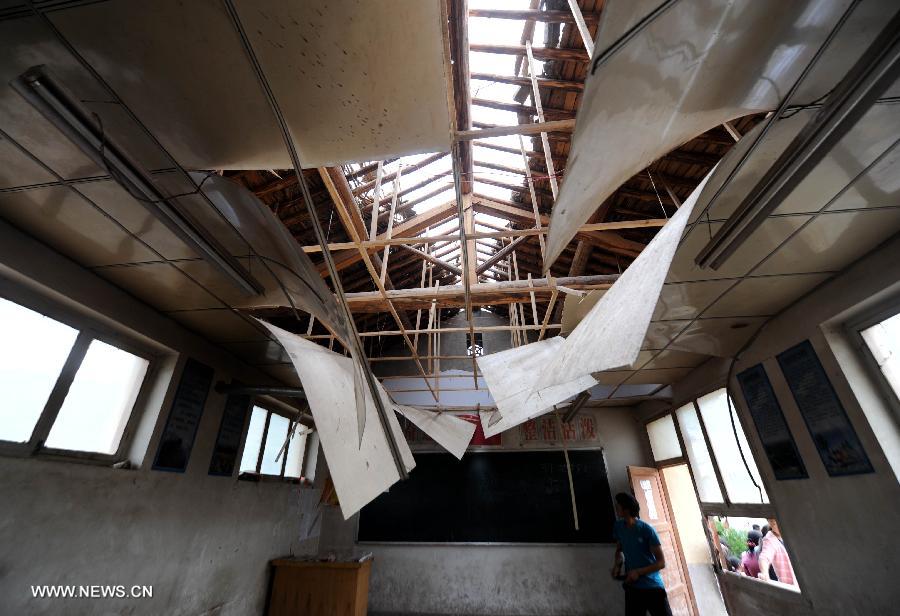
153, 359, 213, 473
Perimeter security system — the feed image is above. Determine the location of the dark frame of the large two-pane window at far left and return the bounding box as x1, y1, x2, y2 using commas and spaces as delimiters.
0, 288, 158, 466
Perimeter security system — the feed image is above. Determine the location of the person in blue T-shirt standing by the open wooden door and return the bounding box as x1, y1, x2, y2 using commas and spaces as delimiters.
612, 492, 672, 616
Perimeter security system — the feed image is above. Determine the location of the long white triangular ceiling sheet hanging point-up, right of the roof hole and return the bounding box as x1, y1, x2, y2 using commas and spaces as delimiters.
535, 169, 715, 390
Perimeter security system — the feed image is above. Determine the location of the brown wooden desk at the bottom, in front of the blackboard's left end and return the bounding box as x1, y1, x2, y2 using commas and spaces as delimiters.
269, 558, 372, 616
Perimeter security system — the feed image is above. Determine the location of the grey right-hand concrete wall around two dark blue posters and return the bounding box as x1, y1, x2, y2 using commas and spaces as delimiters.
660, 238, 900, 616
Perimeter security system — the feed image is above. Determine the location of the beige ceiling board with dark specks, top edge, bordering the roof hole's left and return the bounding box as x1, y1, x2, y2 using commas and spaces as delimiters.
230, 0, 450, 167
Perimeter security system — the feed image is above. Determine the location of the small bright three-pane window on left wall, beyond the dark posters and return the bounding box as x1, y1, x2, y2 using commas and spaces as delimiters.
240, 406, 309, 479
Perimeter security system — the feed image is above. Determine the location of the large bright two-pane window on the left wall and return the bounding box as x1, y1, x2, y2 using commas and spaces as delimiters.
0, 299, 150, 456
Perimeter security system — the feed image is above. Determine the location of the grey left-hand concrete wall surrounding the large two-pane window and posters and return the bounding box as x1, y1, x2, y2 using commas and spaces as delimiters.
0, 222, 318, 616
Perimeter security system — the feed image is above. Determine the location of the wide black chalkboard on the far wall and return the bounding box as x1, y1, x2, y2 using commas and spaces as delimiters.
359, 450, 615, 543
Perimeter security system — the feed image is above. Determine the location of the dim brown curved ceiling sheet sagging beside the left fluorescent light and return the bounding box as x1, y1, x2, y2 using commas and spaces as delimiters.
191, 173, 350, 345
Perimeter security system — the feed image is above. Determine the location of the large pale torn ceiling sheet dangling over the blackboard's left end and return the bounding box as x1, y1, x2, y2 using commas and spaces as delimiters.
260, 321, 416, 519
